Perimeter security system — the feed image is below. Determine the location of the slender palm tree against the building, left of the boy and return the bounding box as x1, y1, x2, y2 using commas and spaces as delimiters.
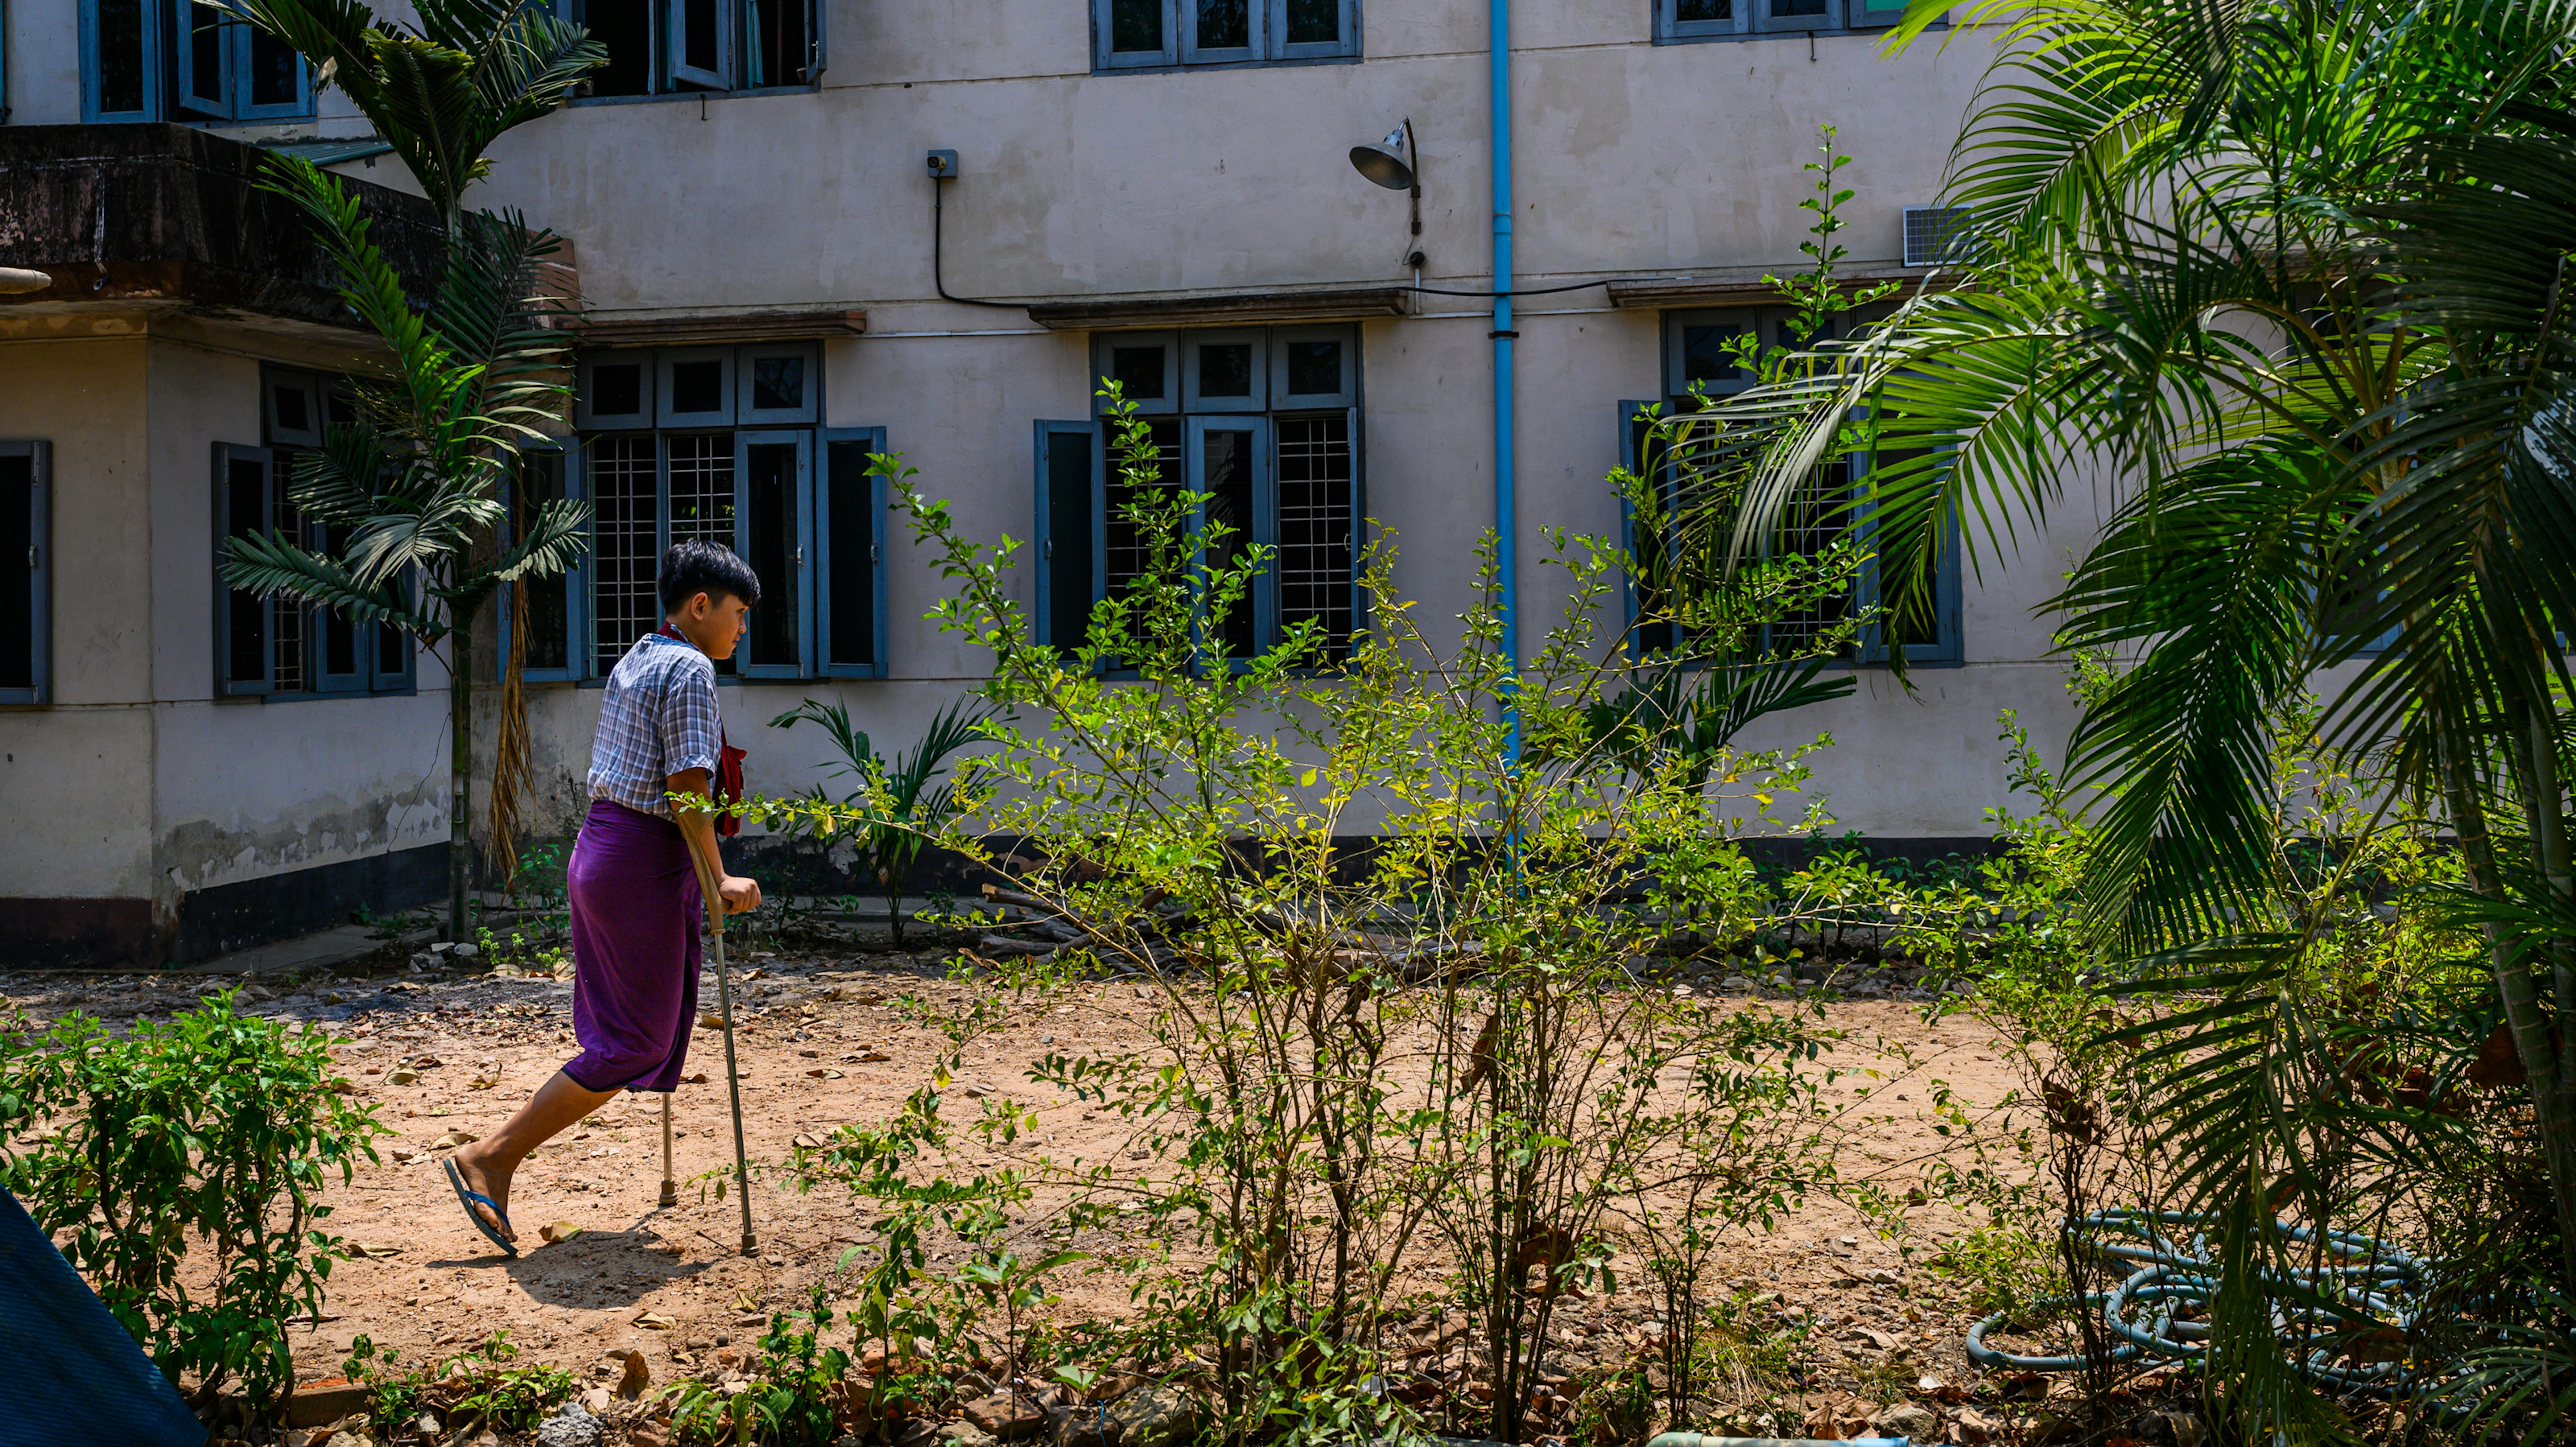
224, 0, 608, 940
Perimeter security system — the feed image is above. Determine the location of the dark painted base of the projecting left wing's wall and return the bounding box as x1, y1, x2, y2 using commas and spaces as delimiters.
0, 844, 448, 968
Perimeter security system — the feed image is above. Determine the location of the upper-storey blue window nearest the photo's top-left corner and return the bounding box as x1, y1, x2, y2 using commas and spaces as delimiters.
80, 0, 314, 121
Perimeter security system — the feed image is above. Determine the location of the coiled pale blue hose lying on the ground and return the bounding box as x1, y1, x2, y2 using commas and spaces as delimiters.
1968, 1210, 2427, 1395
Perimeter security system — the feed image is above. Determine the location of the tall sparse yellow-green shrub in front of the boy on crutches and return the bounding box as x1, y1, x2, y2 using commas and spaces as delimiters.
744, 378, 1937, 1437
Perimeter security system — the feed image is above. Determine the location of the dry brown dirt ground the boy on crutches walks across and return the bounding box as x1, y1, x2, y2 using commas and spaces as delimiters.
0, 927, 2050, 1434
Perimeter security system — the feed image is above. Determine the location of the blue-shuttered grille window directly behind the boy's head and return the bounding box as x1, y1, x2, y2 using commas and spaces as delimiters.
554, 342, 886, 680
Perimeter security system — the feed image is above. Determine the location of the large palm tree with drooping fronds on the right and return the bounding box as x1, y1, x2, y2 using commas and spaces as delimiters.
1669, 0, 2576, 1437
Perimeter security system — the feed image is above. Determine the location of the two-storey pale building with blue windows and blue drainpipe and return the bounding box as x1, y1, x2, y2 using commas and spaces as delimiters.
0, 0, 2089, 960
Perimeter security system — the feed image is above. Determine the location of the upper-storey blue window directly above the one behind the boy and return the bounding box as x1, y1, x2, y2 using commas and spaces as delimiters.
559, 0, 824, 98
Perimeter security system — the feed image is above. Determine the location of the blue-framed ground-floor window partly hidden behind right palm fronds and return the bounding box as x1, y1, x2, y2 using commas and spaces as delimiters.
1620, 309, 1963, 664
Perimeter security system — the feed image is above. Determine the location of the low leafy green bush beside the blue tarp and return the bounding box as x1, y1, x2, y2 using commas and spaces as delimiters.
0, 991, 389, 1406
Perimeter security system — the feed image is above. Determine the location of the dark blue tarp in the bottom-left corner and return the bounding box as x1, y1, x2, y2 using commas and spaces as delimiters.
0, 1190, 206, 1447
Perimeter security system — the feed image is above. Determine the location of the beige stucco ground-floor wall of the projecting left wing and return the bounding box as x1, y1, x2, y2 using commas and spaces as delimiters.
0, 317, 446, 906
